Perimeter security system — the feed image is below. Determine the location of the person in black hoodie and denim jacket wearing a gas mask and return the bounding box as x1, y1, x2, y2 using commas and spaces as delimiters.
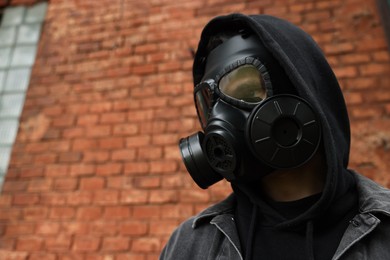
160, 14, 390, 260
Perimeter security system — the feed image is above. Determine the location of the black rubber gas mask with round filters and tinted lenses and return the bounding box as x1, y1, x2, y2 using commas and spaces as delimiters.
179, 35, 321, 189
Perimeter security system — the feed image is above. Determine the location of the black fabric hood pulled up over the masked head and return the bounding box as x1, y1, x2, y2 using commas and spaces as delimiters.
193, 14, 353, 226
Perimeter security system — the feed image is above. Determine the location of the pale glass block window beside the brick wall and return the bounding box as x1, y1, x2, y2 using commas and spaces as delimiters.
0, 2, 47, 190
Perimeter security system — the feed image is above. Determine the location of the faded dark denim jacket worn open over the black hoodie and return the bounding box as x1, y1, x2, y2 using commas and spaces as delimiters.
160, 174, 390, 260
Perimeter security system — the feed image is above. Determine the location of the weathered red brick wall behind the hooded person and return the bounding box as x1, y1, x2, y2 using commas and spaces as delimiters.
0, 0, 390, 260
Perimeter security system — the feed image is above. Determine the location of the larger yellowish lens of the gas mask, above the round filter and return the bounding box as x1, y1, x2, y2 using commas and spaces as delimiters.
218, 64, 267, 103
